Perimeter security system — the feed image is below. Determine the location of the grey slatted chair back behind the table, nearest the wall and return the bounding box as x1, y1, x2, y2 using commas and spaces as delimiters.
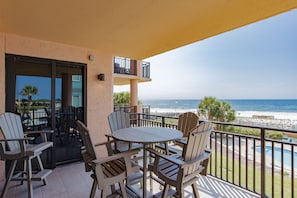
108, 111, 130, 132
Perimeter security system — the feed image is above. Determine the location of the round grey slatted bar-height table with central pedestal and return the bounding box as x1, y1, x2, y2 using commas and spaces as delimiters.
112, 127, 183, 198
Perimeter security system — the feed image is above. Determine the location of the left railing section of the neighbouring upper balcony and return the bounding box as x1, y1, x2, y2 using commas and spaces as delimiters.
114, 56, 137, 75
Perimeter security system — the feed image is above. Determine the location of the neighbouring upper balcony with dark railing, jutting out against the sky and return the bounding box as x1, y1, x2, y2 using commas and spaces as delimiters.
113, 56, 151, 85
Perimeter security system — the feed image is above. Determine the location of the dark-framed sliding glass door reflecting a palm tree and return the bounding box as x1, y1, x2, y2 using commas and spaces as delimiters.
5, 55, 85, 168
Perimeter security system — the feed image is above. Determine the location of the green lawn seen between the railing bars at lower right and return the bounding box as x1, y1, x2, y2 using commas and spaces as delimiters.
208, 152, 297, 197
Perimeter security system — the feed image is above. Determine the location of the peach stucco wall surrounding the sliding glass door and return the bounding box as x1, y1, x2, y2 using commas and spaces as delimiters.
0, 32, 113, 176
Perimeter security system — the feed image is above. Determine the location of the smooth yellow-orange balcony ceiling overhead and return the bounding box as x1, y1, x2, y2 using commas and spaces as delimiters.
0, 0, 297, 60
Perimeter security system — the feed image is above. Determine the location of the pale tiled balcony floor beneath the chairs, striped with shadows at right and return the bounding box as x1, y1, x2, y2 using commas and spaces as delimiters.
0, 162, 259, 198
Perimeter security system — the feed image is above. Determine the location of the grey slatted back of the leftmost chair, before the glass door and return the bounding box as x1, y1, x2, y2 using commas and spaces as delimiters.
0, 112, 24, 151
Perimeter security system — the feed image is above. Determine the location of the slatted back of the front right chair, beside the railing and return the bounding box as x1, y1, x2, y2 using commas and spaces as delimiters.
184, 122, 212, 175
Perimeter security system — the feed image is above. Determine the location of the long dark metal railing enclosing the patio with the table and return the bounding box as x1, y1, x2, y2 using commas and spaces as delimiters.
131, 114, 297, 197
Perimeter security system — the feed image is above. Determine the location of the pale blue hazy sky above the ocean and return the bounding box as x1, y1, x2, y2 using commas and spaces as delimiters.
114, 10, 297, 100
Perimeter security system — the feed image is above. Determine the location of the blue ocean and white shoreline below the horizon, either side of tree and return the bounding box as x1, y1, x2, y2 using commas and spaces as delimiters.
142, 99, 297, 120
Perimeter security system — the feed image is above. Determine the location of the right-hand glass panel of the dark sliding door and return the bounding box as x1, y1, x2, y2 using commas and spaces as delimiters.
55, 63, 84, 163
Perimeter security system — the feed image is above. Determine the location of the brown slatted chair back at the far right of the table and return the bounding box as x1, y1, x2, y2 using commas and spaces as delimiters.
177, 112, 198, 137
